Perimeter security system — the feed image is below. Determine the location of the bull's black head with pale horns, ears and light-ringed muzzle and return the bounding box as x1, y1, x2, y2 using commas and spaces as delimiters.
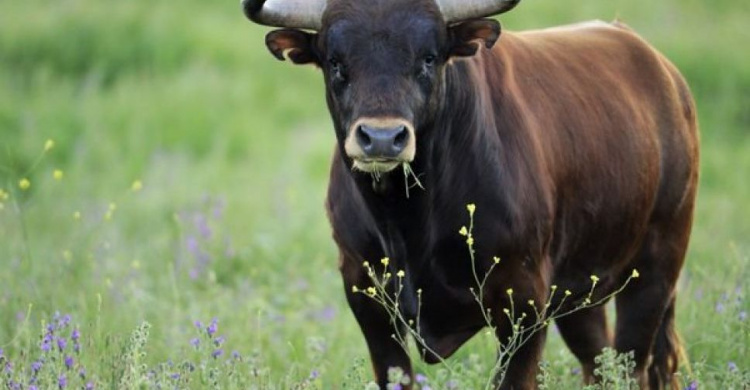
242, 0, 520, 172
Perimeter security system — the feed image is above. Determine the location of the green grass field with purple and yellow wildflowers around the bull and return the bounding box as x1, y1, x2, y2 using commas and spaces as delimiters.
0, 0, 750, 389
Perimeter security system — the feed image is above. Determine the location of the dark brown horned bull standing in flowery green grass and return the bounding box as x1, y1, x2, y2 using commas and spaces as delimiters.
243, 0, 698, 389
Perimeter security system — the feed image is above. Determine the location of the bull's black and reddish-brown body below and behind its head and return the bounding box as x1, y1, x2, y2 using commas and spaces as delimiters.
327, 23, 698, 388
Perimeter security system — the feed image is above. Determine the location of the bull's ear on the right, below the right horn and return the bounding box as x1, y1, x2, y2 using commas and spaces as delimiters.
448, 19, 500, 57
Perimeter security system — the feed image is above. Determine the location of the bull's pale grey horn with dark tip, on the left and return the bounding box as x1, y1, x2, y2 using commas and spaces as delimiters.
242, 0, 326, 30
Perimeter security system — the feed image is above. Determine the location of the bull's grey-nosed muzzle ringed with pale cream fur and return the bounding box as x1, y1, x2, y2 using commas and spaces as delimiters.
345, 118, 416, 172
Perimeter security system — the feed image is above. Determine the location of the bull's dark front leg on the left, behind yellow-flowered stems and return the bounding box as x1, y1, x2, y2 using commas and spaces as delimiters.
341, 259, 414, 390
